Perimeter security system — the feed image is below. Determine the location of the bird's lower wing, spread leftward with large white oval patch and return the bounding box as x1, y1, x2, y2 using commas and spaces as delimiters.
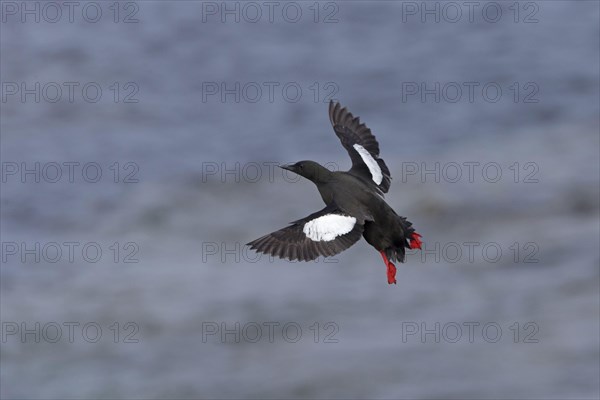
247, 206, 364, 261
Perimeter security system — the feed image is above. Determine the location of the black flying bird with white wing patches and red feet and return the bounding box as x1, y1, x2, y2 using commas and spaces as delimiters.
247, 101, 422, 284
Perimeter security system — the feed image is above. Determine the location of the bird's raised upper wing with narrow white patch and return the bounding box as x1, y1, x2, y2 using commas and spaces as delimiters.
329, 101, 392, 193
